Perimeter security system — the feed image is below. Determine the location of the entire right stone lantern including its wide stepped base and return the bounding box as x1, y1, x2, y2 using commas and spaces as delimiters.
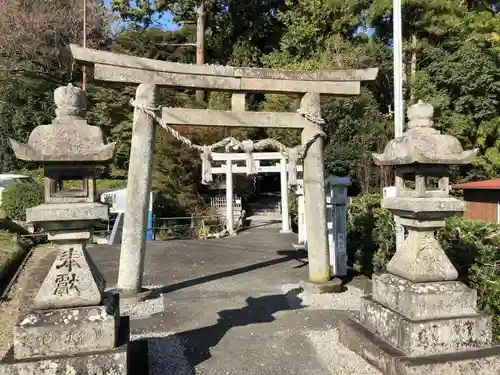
339, 102, 500, 375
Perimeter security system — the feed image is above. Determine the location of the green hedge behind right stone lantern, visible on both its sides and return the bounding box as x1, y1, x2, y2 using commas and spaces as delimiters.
347, 195, 500, 341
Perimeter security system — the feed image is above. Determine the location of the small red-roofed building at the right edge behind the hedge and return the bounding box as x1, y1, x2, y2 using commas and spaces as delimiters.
453, 178, 500, 223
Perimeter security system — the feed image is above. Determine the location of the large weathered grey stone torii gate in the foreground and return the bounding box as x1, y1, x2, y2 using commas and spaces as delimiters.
71, 45, 378, 296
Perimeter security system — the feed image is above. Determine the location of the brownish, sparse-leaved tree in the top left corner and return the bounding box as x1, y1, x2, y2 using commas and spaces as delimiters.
0, 0, 110, 84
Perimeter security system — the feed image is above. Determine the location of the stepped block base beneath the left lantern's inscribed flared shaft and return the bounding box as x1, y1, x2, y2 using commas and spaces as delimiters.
0, 294, 129, 375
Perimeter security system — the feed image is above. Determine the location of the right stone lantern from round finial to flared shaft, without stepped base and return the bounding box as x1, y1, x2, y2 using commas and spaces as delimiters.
373, 102, 477, 282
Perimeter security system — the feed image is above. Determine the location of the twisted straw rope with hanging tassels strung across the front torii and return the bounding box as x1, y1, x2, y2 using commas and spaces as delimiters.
130, 100, 326, 186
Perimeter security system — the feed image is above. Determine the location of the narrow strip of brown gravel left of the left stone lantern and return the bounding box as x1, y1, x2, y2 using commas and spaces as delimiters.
0, 245, 54, 358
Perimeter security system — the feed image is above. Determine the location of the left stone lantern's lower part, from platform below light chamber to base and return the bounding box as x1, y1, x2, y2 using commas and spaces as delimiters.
0, 213, 129, 375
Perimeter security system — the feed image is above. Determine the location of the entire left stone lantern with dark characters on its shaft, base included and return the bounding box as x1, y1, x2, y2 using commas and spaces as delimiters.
0, 84, 128, 375
